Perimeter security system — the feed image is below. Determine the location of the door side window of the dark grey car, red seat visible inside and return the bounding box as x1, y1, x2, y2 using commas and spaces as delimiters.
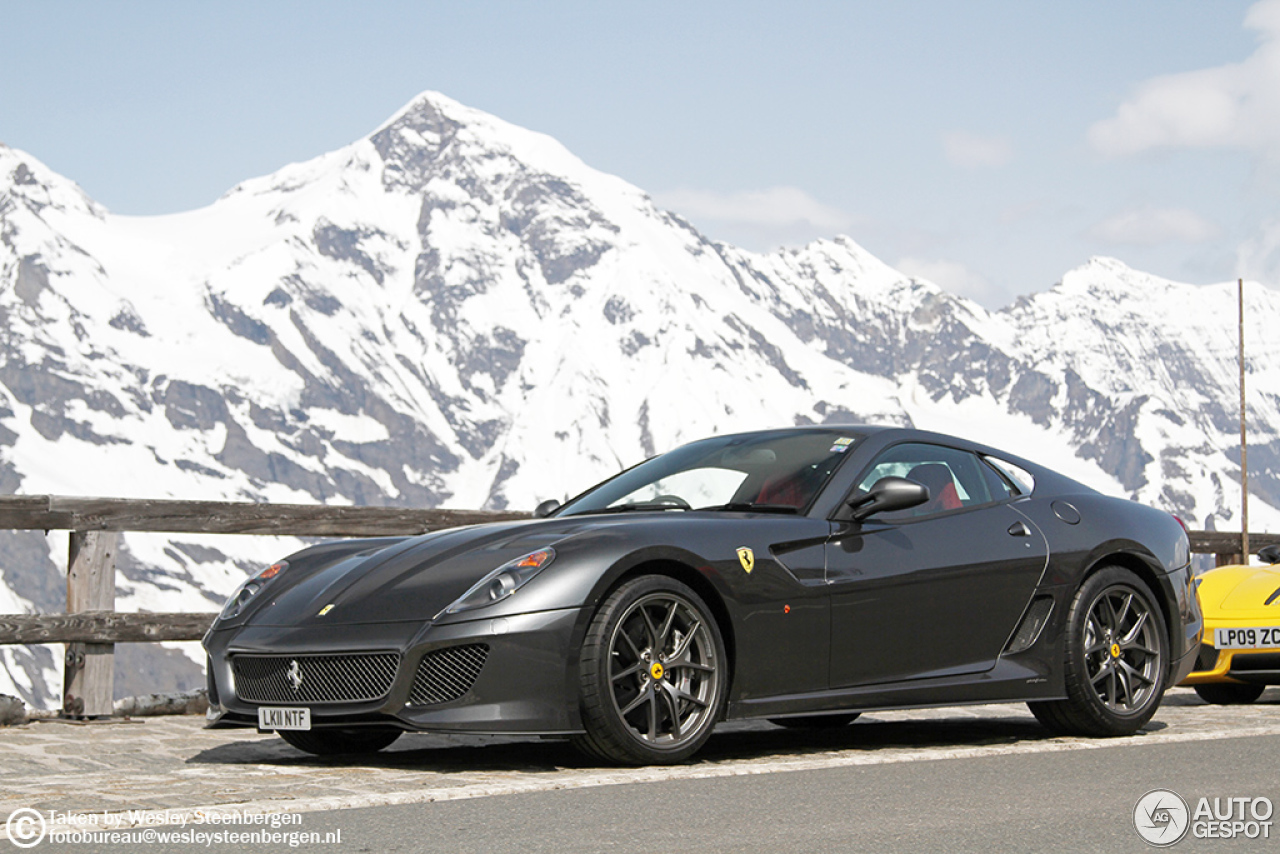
858, 443, 1007, 521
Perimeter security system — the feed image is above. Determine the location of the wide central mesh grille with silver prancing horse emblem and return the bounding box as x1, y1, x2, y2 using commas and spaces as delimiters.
232, 653, 399, 704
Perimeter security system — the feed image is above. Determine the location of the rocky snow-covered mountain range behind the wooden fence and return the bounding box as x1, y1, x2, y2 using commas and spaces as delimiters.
0, 92, 1280, 705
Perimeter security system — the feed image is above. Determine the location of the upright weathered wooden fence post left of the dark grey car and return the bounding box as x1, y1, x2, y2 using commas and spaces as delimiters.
63, 531, 119, 717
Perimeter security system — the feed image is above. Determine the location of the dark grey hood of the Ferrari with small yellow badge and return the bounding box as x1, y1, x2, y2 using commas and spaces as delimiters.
225, 517, 627, 627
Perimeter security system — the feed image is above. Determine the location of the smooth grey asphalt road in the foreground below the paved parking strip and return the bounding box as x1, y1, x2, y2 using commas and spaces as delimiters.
60, 735, 1280, 854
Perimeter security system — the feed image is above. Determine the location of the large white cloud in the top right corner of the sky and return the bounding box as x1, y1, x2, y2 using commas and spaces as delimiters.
1088, 0, 1280, 156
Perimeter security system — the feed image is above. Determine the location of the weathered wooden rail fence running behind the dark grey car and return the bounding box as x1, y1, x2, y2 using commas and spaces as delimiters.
0, 495, 1280, 717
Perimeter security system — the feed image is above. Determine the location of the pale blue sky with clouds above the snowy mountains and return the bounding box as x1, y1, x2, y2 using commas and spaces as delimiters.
0, 0, 1280, 307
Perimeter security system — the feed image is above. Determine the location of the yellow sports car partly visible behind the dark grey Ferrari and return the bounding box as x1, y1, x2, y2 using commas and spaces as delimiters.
1181, 545, 1280, 703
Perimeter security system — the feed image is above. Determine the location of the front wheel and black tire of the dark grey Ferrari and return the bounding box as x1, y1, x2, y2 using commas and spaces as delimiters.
573, 575, 728, 766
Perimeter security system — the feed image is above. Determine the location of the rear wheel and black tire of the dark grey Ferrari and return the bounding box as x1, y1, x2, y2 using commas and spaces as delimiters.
1028, 566, 1169, 736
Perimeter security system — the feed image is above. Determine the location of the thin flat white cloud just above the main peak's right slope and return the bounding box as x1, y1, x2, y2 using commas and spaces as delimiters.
654, 187, 854, 232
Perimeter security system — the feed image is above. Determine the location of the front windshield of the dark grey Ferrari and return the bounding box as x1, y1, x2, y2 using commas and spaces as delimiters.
556, 429, 863, 516
